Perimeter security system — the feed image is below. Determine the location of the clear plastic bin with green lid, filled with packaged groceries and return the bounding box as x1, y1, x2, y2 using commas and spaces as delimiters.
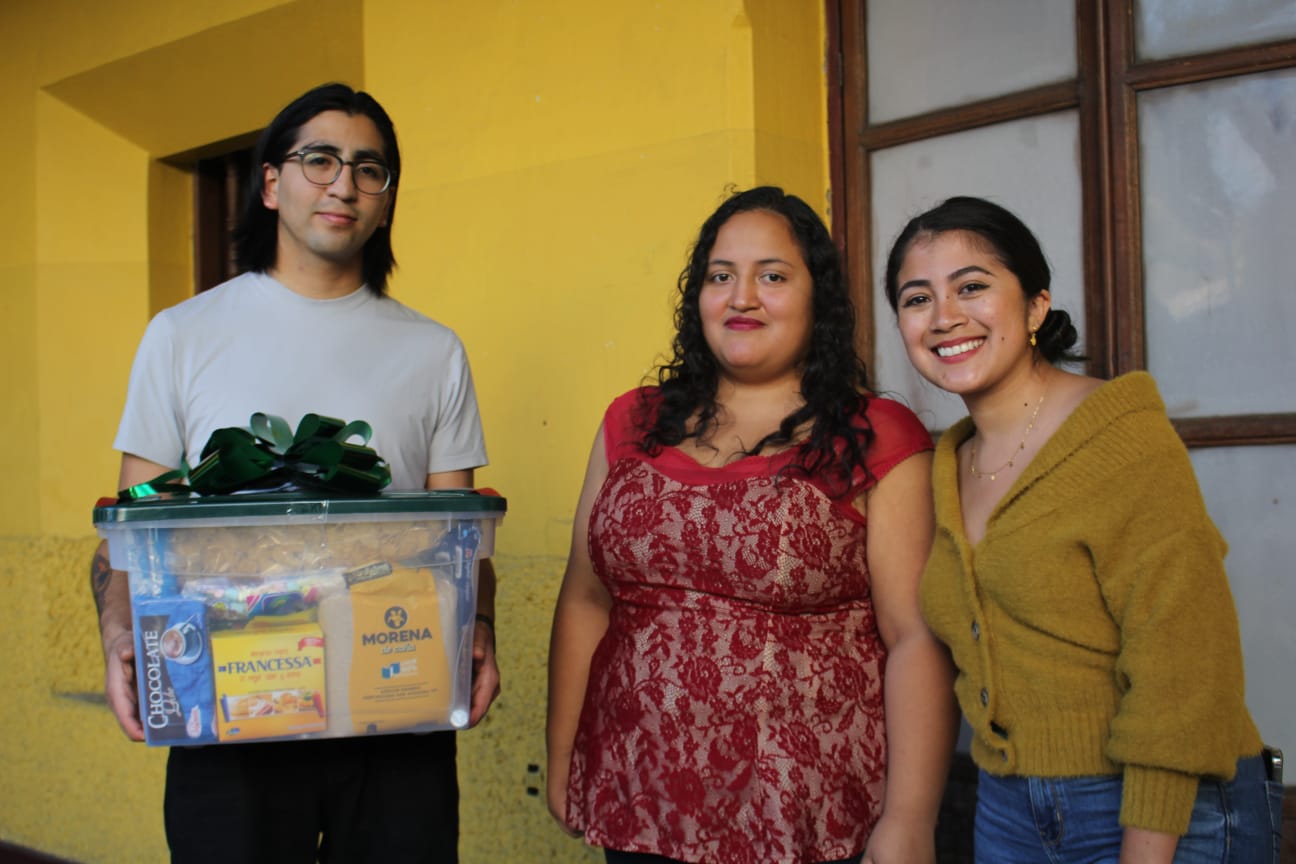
95, 491, 505, 746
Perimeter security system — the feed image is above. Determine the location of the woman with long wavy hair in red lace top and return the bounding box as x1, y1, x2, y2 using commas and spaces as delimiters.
548, 187, 955, 864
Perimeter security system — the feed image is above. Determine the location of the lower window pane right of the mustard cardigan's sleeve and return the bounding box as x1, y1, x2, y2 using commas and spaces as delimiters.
1192, 446, 1296, 756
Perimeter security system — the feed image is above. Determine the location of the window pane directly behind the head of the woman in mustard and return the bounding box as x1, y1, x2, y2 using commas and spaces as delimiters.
871, 111, 1085, 429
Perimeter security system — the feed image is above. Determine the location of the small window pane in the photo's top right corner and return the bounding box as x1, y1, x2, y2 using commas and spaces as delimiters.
1135, 0, 1296, 60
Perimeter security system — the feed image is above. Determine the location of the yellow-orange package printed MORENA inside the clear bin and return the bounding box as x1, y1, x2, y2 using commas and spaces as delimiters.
350, 567, 452, 733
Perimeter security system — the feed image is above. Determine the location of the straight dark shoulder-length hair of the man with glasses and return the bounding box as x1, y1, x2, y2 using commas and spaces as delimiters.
233, 84, 400, 297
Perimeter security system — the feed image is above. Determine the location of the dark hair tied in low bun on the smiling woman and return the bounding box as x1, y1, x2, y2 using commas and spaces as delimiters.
884, 196, 1085, 363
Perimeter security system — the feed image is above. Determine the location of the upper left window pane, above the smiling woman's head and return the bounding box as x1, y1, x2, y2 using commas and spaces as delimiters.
868, 0, 1076, 123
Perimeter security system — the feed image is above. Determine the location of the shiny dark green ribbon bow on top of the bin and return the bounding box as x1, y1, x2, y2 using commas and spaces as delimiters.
118, 412, 391, 501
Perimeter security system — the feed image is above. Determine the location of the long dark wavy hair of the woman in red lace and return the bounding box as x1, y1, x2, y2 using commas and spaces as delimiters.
640, 187, 872, 495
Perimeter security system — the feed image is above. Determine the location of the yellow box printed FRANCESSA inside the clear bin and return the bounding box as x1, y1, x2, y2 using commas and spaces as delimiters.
211, 624, 328, 741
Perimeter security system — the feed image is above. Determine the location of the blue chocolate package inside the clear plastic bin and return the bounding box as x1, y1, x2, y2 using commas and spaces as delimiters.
135, 597, 216, 745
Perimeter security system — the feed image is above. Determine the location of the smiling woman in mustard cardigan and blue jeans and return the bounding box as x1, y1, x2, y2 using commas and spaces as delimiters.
885, 198, 1282, 864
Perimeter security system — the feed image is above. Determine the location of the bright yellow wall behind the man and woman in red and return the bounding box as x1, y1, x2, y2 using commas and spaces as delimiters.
0, 0, 828, 864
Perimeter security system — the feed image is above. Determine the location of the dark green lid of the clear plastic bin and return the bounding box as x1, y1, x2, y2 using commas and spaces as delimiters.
95, 490, 508, 529
